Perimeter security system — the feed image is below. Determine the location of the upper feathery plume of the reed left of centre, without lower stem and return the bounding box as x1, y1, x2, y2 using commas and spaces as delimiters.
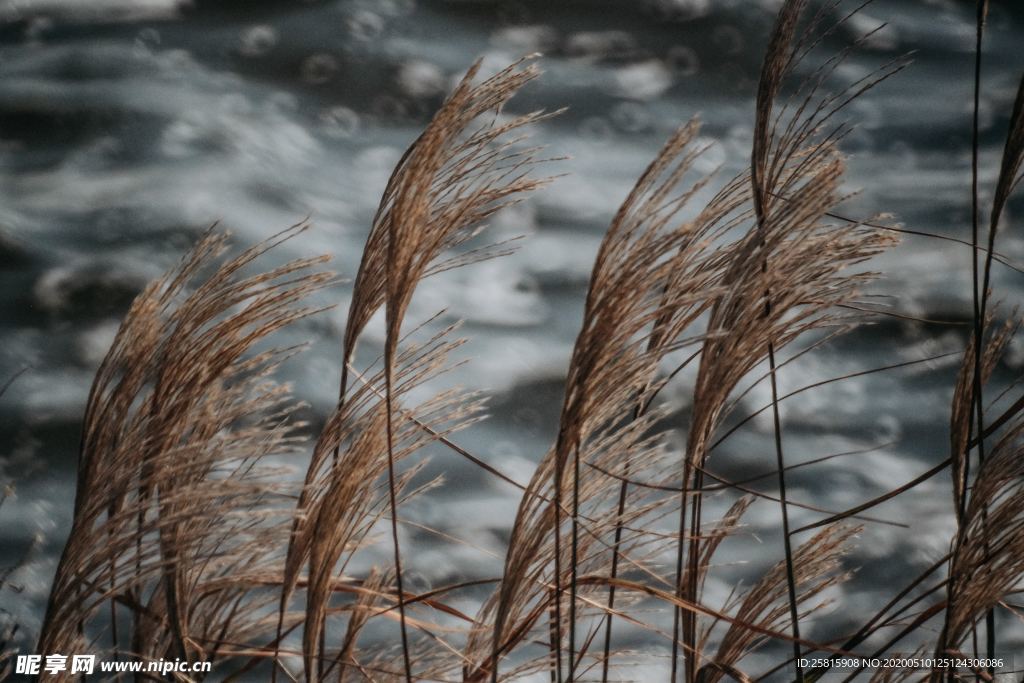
341, 60, 557, 400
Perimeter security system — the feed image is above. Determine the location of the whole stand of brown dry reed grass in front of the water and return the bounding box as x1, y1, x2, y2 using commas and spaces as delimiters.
14, 0, 1024, 683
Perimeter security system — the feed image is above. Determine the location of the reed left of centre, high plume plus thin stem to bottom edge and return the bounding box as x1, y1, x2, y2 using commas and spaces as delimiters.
354, 58, 544, 681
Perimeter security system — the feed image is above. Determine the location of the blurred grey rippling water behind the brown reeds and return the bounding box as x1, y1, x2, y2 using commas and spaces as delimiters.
0, 0, 1024, 678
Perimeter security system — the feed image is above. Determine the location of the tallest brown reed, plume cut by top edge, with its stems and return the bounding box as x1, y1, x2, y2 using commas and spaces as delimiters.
672, 0, 904, 681
